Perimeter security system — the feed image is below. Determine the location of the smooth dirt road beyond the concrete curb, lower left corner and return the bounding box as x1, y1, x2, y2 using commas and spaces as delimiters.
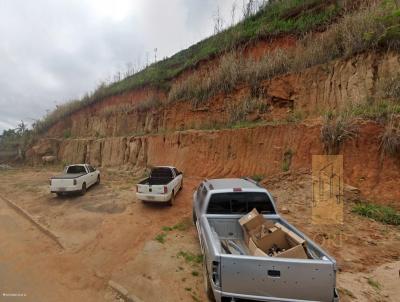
0, 192, 102, 302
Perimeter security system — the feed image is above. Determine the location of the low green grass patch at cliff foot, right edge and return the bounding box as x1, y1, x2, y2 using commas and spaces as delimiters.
352, 203, 400, 225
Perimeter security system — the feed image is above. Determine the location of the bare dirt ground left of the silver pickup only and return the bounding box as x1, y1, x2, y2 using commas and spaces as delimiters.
0, 169, 204, 302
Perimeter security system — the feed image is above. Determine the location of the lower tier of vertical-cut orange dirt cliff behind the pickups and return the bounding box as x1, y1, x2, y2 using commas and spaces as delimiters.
31, 120, 400, 208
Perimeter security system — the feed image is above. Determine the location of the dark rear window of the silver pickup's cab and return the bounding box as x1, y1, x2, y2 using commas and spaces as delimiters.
207, 192, 275, 214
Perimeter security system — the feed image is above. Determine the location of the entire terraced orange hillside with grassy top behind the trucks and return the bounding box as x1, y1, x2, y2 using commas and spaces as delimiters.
26, 0, 400, 207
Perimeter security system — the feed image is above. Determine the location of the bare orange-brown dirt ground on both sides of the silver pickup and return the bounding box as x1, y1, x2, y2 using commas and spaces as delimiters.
0, 168, 400, 302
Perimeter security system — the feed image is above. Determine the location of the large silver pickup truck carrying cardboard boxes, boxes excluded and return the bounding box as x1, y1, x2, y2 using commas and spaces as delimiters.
193, 179, 339, 302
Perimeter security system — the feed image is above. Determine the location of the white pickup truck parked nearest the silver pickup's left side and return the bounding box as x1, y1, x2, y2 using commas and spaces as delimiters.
136, 166, 183, 205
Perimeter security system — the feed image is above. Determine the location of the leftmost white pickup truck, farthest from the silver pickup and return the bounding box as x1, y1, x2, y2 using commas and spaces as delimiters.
50, 164, 100, 196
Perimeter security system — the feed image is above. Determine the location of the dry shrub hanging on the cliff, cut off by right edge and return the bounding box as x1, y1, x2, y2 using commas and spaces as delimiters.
380, 117, 400, 158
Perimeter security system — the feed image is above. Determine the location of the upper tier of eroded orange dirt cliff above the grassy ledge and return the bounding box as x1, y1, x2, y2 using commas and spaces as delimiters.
46, 52, 400, 138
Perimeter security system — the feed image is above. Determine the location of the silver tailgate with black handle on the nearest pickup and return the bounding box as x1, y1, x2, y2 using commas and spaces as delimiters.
220, 255, 335, 301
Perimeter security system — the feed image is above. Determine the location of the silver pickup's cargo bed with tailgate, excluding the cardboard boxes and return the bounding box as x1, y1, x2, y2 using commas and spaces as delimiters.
203, 215, 335, 301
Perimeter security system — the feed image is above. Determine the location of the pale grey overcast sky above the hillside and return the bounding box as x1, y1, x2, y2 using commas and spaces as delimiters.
0, 0, 243, 133
